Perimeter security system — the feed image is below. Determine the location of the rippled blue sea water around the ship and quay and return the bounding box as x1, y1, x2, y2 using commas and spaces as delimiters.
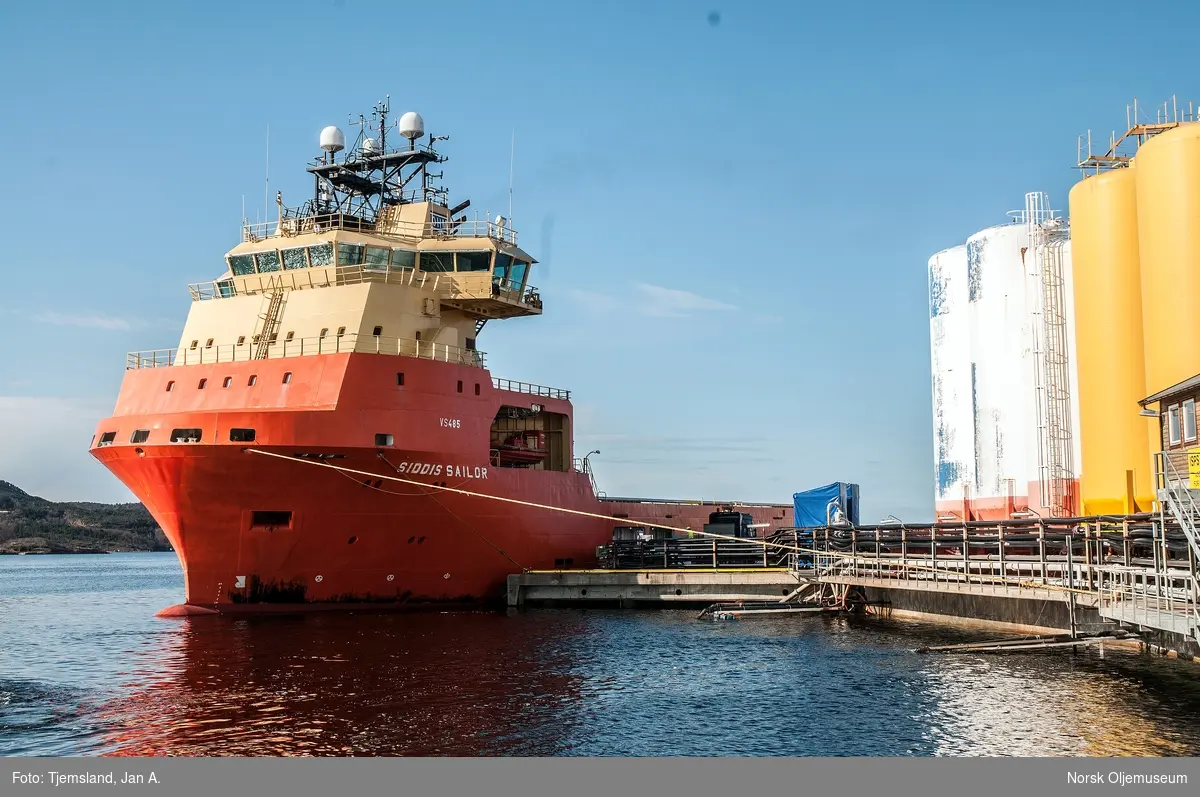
0, 553, 1200, 755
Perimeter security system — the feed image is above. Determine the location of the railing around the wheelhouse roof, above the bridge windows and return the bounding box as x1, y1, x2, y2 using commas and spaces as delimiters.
241, 214, 517, 246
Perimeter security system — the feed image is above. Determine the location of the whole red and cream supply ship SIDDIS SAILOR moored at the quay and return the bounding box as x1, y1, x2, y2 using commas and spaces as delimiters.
91, 103, 792, 613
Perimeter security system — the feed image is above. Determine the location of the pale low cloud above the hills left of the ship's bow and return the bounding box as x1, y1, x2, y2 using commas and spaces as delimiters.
0, 396, 133, 502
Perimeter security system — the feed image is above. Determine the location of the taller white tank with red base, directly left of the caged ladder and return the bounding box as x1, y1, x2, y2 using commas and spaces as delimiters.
967, 223, 1032, 520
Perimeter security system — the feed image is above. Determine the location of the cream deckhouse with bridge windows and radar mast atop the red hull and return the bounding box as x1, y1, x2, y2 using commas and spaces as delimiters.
132, 106, 541, 366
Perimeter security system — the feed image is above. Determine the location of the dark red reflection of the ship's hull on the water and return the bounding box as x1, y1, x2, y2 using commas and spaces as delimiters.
93, 613, 577, 756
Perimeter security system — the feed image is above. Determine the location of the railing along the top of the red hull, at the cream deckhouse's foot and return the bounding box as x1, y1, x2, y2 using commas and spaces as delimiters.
125, 332, 486, 370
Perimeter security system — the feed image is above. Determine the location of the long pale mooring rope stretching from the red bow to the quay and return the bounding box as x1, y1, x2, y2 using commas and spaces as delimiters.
242, 448, 1094, 595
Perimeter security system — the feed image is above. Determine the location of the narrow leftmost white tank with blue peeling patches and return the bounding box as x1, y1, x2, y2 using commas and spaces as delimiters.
929, 246, 976, 514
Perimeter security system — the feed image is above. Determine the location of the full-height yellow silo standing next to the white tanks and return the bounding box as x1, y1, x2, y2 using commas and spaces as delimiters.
1070, 166, 1153, 515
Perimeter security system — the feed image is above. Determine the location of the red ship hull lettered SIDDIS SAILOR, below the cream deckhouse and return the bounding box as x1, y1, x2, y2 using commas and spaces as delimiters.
91, 353, 792, 611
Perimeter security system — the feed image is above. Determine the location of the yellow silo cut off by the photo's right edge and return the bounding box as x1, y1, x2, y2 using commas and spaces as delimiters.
1136, 122, 1200, 392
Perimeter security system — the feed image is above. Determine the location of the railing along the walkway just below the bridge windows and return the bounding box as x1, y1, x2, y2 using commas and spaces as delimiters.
187, 265, 542, 308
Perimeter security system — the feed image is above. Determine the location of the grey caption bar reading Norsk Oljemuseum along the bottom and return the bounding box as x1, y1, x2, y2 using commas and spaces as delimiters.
0, 757, 1200, 797
